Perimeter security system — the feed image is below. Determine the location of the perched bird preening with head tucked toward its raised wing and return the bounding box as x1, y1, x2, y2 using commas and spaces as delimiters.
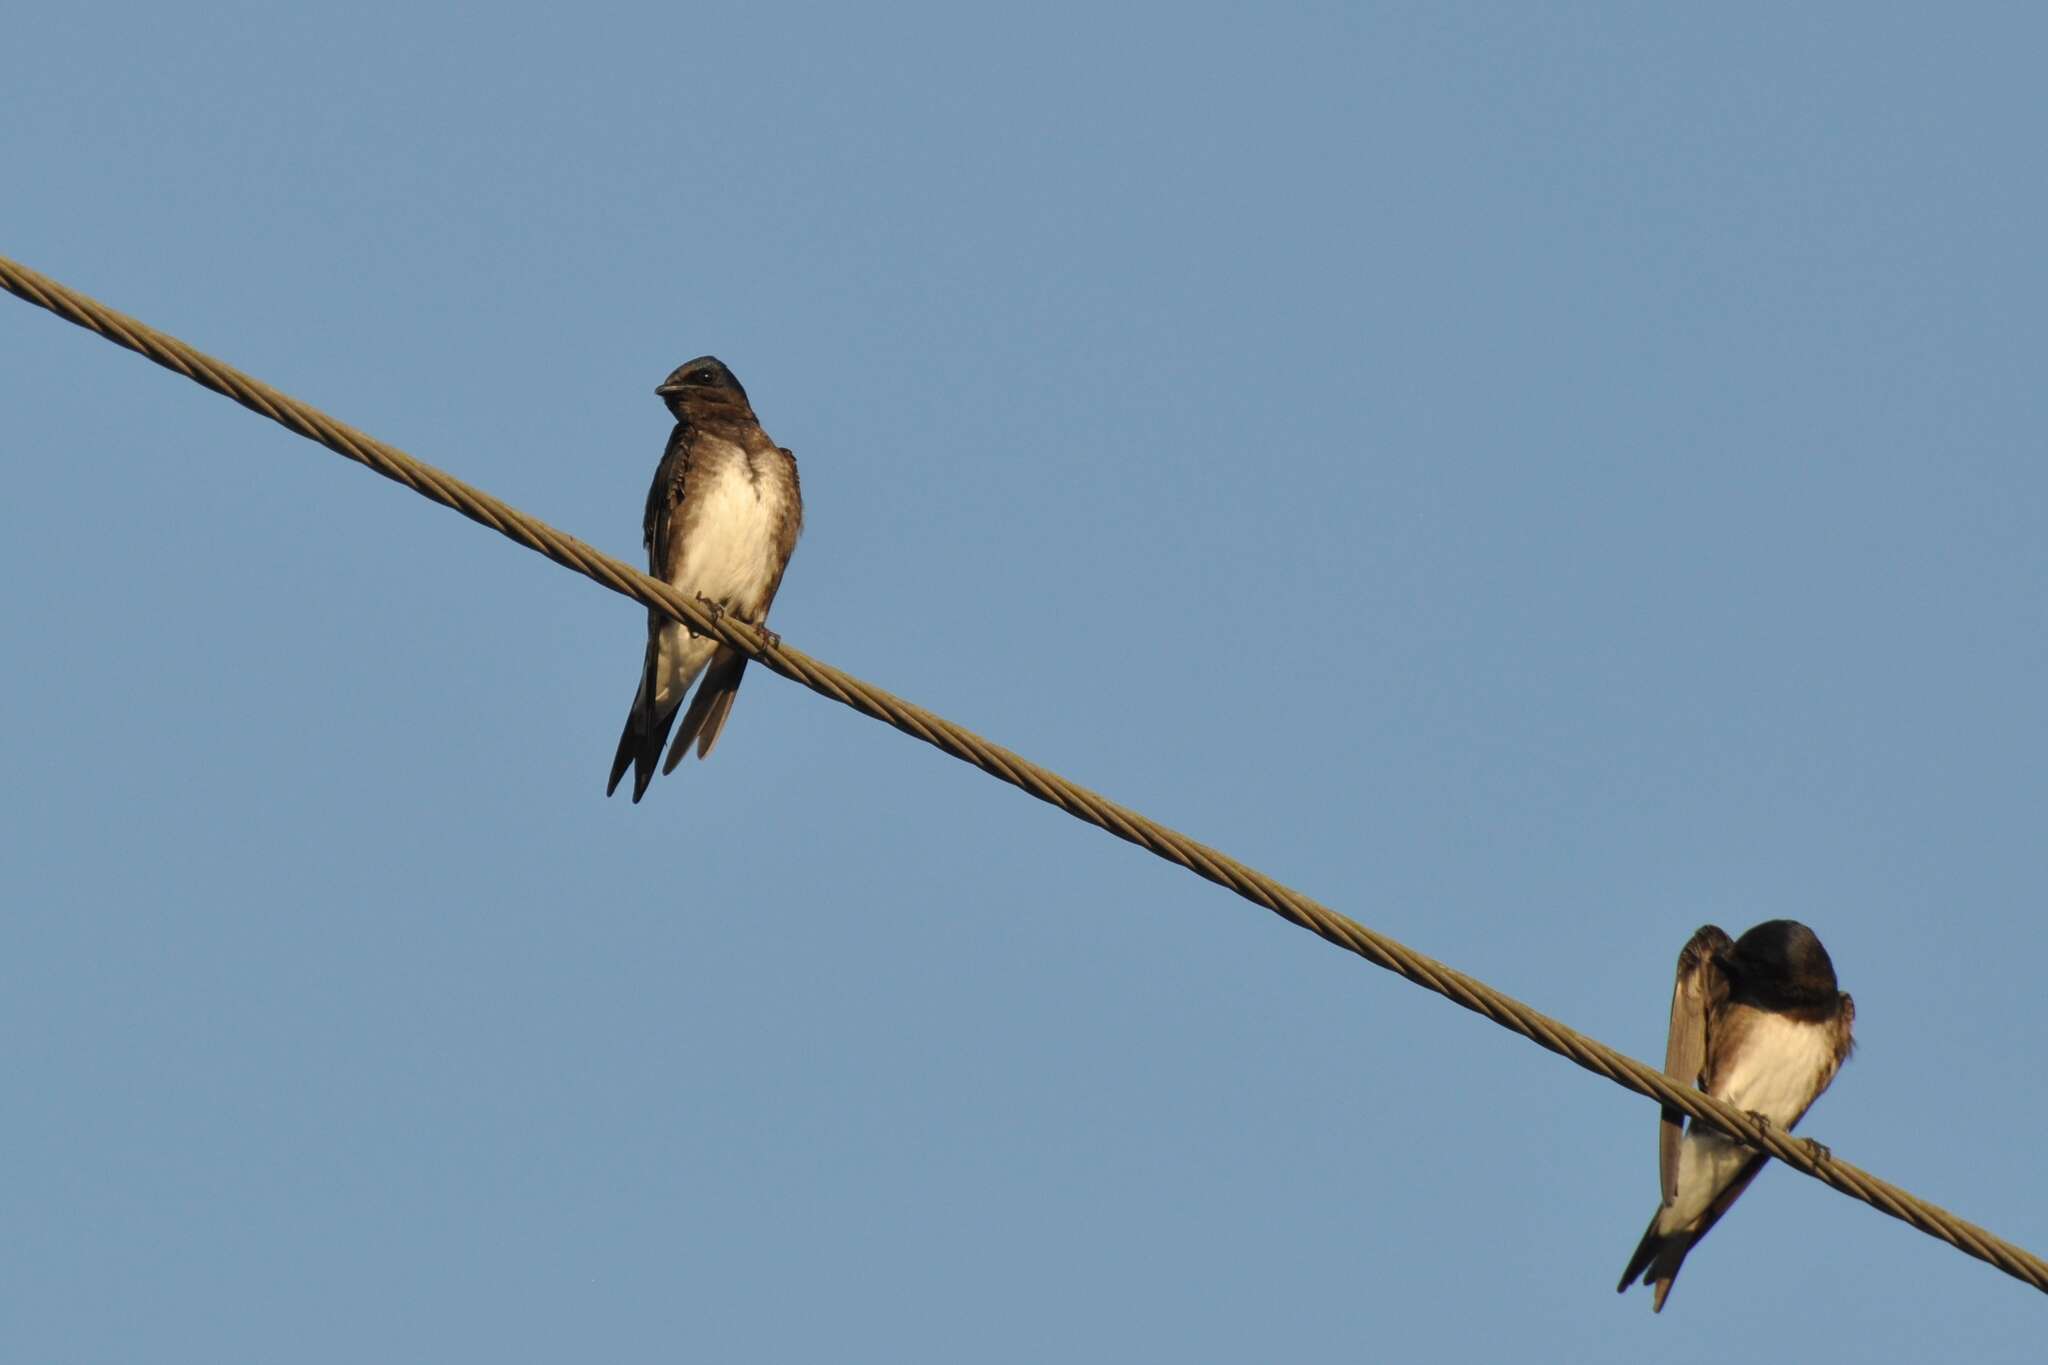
1618, 919, 1855, 1312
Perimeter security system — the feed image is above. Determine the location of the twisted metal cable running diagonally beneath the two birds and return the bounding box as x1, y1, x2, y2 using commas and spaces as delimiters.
0, 256, 2048, 1293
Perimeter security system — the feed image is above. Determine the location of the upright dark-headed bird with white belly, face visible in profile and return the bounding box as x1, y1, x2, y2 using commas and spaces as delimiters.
604, 356, 803, 802
